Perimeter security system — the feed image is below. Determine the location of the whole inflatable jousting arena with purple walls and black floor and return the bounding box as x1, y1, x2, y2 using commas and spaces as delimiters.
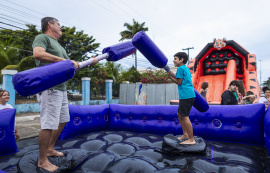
0, 104, 270, 173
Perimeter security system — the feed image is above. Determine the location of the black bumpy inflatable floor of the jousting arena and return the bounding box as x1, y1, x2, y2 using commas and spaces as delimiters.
0, 131, 270, 173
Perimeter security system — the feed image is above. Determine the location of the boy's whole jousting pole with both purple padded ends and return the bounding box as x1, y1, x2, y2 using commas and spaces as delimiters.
132, 31, 209, 112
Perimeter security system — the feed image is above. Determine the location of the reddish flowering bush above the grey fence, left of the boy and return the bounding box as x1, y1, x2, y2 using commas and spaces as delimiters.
139, 70, 171, 83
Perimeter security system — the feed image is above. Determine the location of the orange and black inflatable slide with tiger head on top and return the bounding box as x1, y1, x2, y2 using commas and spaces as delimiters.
188, 38, 260, 104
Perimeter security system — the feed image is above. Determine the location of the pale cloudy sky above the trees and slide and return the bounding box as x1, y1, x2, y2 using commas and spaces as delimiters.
0, 0, 270, 84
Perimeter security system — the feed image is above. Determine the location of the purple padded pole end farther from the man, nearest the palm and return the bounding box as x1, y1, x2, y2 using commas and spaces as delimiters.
102, 41, 136, 61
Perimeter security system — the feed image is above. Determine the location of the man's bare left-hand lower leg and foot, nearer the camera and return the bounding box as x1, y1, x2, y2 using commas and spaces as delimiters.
38, 129, 58, 172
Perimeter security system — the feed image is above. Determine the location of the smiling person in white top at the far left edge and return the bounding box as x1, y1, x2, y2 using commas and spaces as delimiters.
0, 89, 20, 140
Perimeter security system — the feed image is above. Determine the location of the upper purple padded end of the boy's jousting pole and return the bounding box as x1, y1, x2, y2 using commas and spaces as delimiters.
132, 31, 168, 68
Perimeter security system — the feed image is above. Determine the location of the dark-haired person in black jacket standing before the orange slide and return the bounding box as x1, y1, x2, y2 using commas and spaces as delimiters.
221, 80, 239, 105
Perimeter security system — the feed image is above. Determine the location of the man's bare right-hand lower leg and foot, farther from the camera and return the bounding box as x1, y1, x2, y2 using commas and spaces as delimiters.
47, 123, 67, 157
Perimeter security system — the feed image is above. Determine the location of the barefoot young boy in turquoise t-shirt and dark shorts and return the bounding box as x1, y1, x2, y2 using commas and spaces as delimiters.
168, 52, 196, 145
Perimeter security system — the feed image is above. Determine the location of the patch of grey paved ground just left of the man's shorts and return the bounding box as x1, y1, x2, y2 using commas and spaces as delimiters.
15, 112, 40, 139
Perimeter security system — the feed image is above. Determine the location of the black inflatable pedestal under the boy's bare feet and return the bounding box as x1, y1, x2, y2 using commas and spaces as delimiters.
162, 134, 206, 155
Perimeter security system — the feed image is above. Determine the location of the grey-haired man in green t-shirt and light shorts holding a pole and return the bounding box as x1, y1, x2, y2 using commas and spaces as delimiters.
32, 17, 98, 172
